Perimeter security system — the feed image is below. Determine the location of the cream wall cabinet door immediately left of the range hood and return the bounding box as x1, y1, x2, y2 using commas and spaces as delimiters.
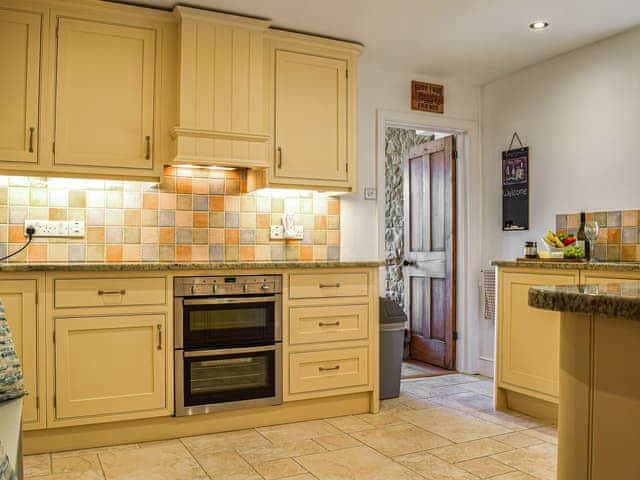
54, 18, 155, 171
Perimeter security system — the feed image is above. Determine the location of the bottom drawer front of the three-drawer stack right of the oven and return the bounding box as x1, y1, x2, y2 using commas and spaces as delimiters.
289, 347, 369, 394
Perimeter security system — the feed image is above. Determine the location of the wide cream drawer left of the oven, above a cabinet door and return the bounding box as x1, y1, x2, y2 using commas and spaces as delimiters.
54, 277, 167, 308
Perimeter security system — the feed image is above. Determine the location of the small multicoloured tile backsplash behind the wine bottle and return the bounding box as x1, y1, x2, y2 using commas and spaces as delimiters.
556, 210, 640, 262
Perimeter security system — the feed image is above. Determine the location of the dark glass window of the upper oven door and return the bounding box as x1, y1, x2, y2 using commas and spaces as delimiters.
184, 300, 275, 348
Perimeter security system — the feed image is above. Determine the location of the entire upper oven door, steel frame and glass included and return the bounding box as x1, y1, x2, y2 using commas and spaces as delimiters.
175, 295, 282, 350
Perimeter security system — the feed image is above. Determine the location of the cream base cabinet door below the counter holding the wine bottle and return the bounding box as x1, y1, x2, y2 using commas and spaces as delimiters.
498, 271, 579, 403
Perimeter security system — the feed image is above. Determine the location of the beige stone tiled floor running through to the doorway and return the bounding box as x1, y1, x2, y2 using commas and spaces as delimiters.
25, 374, 556, 480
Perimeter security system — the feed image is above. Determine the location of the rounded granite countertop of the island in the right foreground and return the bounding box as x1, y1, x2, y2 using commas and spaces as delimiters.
529, 281, 640, 320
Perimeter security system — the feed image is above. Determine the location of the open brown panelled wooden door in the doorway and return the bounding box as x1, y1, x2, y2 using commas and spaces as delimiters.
404, 136, 456, 369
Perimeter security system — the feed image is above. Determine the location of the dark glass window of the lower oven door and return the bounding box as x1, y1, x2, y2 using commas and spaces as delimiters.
184, 351, 276, 407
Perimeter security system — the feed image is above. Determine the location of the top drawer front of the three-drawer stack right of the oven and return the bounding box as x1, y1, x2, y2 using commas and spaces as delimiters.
289, 273, 369, 298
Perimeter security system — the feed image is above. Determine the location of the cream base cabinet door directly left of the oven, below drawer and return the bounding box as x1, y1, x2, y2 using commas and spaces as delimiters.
55, 314, 166, 419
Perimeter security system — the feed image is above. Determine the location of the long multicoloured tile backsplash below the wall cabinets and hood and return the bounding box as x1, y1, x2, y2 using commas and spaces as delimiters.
0, 167, 340, 263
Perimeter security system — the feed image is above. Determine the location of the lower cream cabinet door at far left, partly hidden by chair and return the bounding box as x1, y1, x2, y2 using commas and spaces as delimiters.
0, 280, 40, 428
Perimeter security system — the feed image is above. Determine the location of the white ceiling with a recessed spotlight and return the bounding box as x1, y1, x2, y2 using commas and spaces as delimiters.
112, 0, 640, 84
